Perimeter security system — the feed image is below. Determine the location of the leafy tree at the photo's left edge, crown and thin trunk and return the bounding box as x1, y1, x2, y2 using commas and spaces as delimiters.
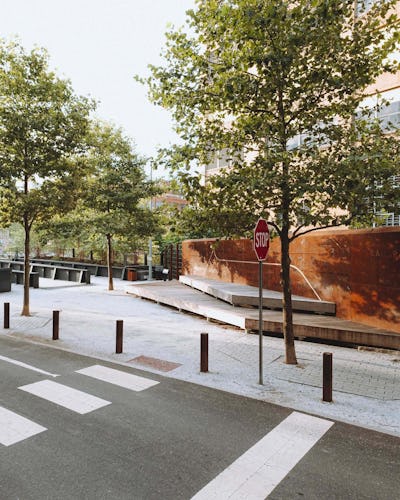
0, 42, 93, 315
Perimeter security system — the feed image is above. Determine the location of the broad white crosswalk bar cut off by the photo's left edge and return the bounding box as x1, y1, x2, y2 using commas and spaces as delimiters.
0, 406, 47, 446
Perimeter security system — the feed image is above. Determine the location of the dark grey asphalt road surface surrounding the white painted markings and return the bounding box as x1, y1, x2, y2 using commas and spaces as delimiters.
0, 337, 400, 500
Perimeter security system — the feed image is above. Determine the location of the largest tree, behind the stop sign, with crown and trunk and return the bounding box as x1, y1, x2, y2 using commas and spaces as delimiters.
146, 0, 399, 364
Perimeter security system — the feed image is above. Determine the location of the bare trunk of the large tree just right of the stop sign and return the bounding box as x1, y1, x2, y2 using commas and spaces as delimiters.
281, 229, 297, 365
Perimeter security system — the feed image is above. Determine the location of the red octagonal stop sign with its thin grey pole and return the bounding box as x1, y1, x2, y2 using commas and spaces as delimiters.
253, 218, 269, 385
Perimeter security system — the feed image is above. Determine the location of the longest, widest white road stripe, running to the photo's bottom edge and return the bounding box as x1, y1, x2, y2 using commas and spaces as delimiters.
193, 412, 333, 500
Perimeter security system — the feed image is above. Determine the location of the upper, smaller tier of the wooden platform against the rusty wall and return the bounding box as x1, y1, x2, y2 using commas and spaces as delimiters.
179, 275, 336, 315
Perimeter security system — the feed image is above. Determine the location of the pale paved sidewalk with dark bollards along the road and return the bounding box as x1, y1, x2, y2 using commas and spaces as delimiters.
0, 278, 400, 436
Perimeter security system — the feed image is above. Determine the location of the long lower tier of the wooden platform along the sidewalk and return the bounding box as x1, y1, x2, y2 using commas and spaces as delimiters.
125, 280, 400, 349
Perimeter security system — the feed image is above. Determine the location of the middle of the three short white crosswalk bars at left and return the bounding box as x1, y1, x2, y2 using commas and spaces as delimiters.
18, 380, 111, 415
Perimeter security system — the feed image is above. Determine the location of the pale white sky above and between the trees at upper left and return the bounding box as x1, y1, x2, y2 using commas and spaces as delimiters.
0, 0, 195, 176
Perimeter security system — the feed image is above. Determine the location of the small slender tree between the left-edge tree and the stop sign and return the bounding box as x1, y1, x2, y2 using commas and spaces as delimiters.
81, 123, 157, 290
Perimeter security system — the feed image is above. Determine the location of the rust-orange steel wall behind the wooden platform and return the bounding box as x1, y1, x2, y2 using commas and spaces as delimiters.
182, 228, 400, 333
